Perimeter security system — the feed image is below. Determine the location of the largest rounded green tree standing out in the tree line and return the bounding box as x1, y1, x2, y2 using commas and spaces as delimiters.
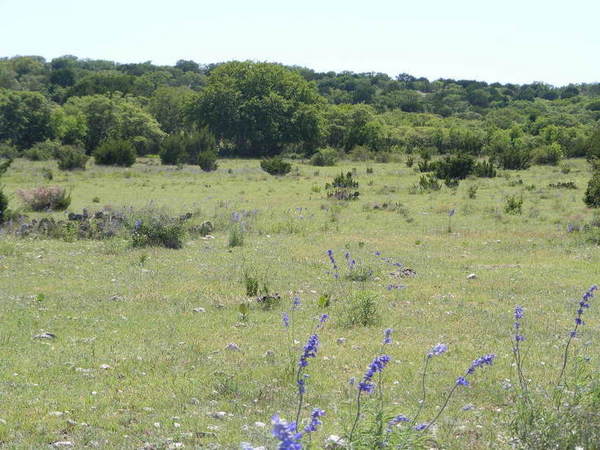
188, 62, 322, 156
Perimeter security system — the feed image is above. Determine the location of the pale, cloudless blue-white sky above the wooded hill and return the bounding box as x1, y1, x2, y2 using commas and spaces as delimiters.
0, 0, 600, 85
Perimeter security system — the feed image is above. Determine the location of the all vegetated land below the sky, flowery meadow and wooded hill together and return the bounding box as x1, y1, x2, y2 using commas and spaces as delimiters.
0, 56, 600, 449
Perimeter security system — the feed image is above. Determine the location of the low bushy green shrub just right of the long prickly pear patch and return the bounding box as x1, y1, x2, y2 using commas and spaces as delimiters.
132, 216, 185, 249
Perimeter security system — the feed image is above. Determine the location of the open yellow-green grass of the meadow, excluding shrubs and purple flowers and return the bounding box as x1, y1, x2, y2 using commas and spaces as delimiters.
0, 159, 600, 449
